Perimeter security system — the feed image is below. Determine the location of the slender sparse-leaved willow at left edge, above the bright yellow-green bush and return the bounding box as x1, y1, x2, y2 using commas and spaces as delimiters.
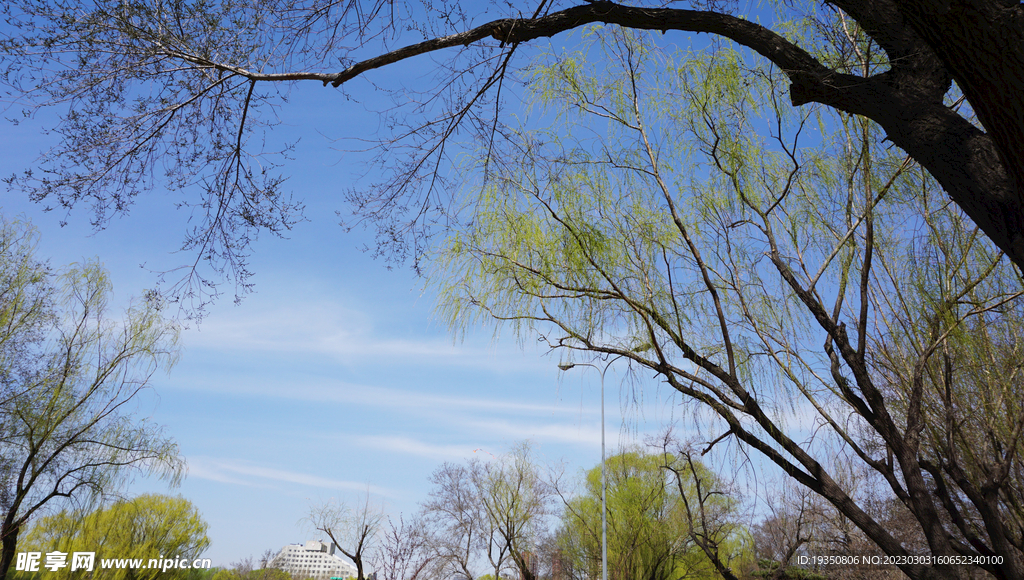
0, 217, 184, 579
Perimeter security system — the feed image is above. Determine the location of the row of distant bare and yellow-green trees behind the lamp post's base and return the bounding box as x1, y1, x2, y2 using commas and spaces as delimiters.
313, 433, 942, 580
